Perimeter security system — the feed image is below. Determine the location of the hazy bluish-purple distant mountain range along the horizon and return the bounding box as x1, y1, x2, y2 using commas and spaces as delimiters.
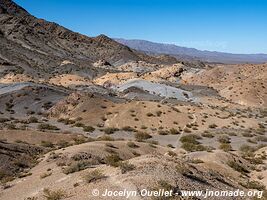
115, 38, 267, 64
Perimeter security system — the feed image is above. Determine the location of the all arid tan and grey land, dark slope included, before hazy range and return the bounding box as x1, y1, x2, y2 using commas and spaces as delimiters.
0, 0, 267, 200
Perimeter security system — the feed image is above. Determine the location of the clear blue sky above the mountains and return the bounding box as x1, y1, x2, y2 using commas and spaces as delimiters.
15, 0, 267, 53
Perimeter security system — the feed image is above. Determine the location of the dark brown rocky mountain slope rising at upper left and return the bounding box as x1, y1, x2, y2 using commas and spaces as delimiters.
0, 0, 178, 78
